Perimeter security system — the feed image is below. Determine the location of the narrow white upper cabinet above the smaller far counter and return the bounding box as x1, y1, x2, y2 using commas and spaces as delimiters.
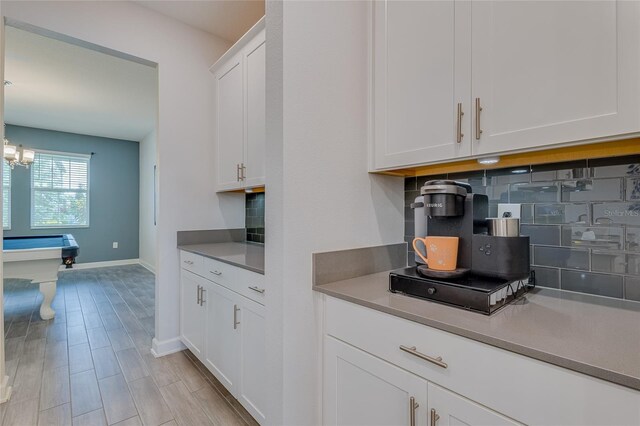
210, 18, 266, 191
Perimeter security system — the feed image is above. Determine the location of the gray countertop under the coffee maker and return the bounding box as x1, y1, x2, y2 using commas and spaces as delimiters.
314, 271, 640, 390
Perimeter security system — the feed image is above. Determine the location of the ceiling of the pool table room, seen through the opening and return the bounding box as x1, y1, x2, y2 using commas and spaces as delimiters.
5, 26, 158, 141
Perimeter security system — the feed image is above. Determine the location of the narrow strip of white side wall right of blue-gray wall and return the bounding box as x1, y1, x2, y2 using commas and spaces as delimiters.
138, 130, 157, 272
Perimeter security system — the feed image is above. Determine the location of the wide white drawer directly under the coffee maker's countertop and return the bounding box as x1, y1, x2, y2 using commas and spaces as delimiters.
325, 297, 640, 425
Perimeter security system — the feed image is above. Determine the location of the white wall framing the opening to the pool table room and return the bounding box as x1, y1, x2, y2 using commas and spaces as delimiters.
2, 1, 244, 352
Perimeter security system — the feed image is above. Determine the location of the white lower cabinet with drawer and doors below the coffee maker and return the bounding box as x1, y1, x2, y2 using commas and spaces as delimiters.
323, 296, 640, 426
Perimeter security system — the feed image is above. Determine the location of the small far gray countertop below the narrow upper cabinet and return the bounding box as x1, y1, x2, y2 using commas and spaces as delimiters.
178, 242, 264, 275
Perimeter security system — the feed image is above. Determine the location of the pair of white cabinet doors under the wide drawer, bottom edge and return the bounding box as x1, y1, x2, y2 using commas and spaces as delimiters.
324, 336, 519, 426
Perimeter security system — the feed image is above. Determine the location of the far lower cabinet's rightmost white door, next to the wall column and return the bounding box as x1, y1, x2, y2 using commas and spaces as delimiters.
238, 296, 267, 424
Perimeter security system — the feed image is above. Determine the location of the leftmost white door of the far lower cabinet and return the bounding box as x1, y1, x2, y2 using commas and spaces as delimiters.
180, 269, 206, 358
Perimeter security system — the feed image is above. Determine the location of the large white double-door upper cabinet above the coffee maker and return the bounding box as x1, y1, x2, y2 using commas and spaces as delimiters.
371, 0, 640, 170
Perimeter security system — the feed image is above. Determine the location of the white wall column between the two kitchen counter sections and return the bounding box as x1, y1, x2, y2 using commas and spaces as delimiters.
266, 1, 404, 425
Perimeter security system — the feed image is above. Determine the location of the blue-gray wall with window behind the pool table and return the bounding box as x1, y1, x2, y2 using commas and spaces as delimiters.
4, 124, 140, 263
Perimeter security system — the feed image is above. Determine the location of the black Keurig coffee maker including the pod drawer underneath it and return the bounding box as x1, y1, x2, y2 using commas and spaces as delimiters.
389, 180, 530, 314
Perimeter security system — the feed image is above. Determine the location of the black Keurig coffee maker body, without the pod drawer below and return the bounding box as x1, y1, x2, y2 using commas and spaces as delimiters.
416, 180, 530, 280
